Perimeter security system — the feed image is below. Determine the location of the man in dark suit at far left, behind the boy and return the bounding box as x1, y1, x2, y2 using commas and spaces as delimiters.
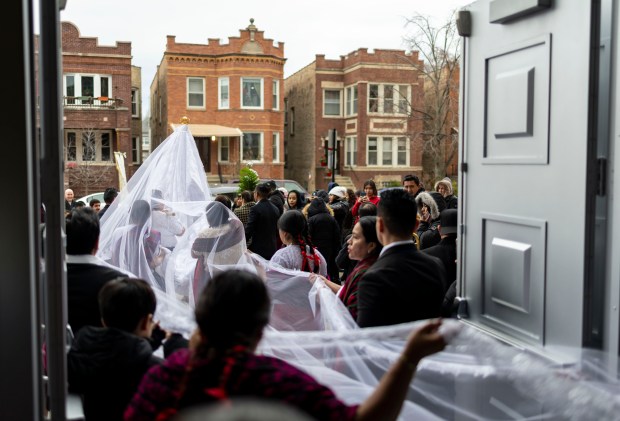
67, 208, 129, 333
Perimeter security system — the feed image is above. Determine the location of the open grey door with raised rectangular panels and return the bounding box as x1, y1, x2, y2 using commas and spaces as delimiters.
459, 0, 592, 346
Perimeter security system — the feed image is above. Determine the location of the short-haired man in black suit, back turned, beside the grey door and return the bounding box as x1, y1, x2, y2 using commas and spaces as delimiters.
357, 189, 446, 327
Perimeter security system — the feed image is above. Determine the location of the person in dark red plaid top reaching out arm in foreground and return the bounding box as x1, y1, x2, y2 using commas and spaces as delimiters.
125, 270, 445, 421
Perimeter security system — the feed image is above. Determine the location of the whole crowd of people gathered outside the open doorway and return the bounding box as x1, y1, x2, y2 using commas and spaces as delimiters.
59, 124, 454, 420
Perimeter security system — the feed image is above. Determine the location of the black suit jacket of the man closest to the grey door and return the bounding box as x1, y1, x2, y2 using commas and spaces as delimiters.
357, 243, 446, 327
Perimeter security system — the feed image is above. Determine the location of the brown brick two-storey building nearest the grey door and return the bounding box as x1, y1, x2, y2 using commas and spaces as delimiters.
284, 48, 424, 190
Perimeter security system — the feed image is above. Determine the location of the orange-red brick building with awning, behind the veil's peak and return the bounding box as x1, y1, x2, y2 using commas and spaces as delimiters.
150, 19, 285, 179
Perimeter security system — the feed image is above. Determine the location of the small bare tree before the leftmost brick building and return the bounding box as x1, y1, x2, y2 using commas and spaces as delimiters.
67, 128, 107, 194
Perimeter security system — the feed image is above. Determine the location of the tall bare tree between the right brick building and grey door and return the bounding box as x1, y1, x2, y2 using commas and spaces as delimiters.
405, 14, 460, 181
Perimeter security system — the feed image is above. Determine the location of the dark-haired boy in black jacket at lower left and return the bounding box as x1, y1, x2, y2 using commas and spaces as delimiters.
67, 278, 187, 421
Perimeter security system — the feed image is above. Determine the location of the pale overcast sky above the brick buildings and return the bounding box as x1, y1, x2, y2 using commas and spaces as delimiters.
60, 0, 473, 113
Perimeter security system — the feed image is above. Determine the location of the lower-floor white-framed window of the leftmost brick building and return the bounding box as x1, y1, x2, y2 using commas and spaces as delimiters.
65, 129, 112, 162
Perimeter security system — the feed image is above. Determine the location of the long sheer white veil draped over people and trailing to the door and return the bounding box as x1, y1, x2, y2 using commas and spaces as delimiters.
99, 125, 620, 420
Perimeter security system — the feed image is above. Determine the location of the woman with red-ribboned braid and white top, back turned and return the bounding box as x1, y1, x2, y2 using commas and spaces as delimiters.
271, 210, 327, 276
